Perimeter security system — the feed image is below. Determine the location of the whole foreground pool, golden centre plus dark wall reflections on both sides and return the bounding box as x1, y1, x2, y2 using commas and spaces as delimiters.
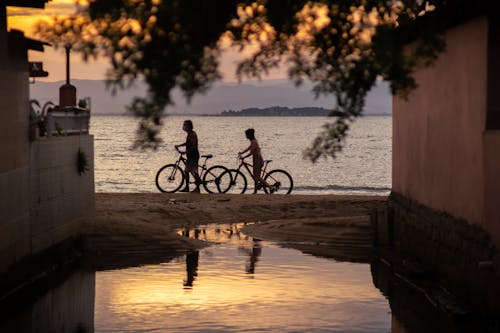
0, 224, 494, 333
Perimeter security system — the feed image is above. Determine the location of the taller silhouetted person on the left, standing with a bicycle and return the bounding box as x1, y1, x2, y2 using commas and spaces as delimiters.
175, 120, 201, 193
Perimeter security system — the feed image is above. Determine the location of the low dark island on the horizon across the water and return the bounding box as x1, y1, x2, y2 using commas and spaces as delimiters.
220, 106, 342, 117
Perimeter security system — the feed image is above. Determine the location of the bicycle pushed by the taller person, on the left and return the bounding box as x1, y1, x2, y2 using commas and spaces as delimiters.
155, 148, 228, 193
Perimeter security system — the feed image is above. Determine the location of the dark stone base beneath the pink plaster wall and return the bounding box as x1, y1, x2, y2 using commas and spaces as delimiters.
386, 192, 500, 313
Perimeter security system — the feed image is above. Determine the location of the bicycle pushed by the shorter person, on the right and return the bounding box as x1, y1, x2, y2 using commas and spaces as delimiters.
217, 156, 293, 194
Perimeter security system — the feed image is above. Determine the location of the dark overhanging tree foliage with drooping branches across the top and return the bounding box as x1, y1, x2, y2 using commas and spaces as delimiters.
38, 0, 476, 161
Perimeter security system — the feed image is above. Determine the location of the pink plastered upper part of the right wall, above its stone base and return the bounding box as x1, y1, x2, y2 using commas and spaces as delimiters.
392, 17, 486, 226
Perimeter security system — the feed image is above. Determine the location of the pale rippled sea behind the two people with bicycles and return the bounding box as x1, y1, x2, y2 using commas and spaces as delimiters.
90, 116, 392, 195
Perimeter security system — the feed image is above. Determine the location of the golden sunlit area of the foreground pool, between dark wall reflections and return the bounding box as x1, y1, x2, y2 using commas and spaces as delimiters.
96, 226, 390, 332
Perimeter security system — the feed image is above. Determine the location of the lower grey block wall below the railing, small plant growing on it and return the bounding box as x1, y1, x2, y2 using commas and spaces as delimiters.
30, 135, 95, 253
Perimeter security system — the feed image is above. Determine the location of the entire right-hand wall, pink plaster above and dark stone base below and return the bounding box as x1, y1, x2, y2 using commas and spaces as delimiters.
388, 17, 500, 314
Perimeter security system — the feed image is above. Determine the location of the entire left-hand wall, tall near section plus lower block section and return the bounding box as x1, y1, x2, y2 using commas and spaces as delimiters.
0, 27, 94, 277
